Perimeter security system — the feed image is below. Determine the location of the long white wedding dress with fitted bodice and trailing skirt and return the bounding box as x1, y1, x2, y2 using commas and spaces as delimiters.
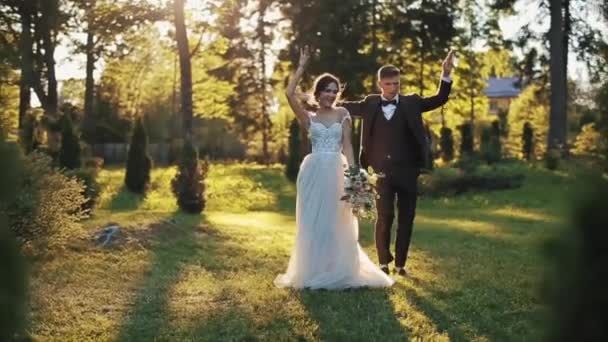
274, 113, 394, 289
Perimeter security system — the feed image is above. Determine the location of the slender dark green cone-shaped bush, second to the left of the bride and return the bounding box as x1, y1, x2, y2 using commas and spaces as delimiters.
125, 118, 152, 194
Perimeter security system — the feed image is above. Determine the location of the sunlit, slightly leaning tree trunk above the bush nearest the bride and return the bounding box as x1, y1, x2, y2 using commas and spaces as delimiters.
173, 0, 193, 140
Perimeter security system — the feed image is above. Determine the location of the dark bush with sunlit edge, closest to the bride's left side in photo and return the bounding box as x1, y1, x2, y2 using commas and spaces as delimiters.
171, 140, 209, 214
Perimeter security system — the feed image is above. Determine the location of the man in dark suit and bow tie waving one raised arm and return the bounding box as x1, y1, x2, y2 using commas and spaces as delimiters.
341, 51, 454, 277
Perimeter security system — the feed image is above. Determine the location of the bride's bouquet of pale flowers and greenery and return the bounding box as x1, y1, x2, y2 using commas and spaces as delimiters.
340, 166, 385, 219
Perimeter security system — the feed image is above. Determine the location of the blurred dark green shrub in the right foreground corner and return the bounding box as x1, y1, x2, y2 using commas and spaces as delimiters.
541, 176, 608, 341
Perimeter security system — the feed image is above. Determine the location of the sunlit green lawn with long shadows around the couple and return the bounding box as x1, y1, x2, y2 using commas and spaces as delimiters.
25, 164, 576, 341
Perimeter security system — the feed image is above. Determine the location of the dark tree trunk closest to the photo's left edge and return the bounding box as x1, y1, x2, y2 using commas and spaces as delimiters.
19, 4, 34, 128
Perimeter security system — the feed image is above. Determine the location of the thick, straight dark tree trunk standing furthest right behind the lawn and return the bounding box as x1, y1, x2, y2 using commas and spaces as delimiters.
547, 0, 567, 149
